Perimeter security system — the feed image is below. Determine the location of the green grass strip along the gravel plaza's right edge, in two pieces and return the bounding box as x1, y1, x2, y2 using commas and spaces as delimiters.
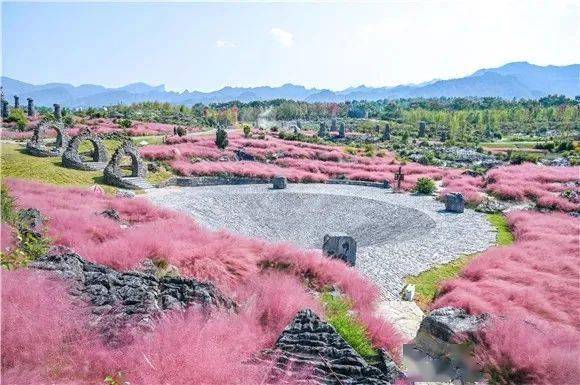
405, 214, 514, 310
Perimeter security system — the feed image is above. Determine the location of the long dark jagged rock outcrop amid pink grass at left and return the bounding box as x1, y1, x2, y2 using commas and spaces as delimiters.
30, 248, 236, 344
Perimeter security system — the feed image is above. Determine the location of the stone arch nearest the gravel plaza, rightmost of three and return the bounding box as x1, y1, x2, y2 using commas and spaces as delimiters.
104, 141, 149, 189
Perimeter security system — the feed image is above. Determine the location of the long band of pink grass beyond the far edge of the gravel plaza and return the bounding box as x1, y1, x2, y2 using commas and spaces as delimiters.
140, 133, 580, 206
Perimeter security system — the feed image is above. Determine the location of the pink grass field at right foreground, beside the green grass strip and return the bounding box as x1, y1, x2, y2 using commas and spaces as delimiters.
433, 212, 580, 385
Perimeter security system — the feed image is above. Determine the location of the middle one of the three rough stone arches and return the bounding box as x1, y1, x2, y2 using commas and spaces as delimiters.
62, 128, 109, 171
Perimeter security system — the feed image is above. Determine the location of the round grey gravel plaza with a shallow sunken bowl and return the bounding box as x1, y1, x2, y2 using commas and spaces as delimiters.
148, 184, 496, 299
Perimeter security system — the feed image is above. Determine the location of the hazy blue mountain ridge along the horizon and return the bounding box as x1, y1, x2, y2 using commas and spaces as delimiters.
1, 62, 580, 107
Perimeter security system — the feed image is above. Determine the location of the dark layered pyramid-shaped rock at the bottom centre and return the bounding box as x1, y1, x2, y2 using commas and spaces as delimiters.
259, 309, 403, 385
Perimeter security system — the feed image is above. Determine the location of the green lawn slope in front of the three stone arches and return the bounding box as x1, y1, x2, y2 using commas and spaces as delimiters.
0, 143, 115, 192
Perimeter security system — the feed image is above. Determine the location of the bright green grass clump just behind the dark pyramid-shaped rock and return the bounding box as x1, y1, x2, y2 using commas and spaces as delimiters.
322, 292, 379, 363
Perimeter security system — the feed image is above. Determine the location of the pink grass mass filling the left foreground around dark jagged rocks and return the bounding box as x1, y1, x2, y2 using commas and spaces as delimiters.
2, 180, 401, 385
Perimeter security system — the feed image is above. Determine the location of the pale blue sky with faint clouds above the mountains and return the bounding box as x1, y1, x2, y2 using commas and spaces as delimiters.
2, 0, 580, 91
